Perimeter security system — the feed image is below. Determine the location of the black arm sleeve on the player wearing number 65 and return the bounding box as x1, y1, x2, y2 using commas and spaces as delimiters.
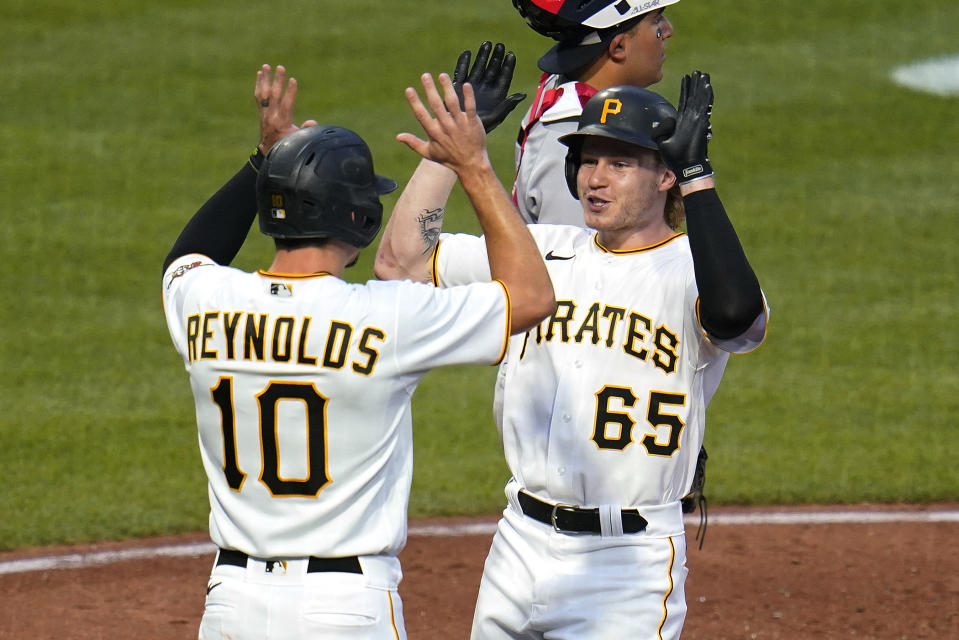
683, 189, 763, 338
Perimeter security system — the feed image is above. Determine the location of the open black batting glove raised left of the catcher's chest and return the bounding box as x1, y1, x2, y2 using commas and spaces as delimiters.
453, 41, 526, 133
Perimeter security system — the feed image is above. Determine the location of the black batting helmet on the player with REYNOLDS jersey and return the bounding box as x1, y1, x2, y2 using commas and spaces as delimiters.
256, 125, 396, 249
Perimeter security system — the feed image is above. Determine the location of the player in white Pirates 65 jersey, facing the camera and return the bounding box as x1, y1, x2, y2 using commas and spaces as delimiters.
376, 72, 768, 640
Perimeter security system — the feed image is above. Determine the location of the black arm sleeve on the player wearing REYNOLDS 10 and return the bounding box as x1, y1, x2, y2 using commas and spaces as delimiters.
163, 151, 263, 273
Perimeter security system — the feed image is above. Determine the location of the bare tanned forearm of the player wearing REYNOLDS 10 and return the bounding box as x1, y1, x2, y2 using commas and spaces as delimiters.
460, 164, 556, 333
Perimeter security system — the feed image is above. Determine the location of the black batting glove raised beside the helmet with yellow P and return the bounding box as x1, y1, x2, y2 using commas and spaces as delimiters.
652, 71, 713, 184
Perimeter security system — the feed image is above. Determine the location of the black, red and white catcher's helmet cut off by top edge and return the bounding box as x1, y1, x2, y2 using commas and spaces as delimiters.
513, 0, 679, 41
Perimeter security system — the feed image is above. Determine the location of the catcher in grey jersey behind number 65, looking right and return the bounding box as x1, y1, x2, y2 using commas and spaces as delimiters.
513, 0, 679, 226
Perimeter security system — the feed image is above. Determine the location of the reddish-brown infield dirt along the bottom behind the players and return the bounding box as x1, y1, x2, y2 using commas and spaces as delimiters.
0, 504, 959, 640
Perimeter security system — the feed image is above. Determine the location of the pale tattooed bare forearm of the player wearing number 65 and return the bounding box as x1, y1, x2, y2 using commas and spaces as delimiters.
373, 160, 456, 282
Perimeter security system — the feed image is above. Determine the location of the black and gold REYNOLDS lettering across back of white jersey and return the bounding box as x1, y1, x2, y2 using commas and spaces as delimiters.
186, 311, 386, 376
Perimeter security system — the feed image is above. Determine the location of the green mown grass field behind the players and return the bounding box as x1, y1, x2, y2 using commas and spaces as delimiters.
0, 0, 959, 549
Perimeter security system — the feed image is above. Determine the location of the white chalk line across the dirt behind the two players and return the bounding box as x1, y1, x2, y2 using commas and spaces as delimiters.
0, 511, 959, 575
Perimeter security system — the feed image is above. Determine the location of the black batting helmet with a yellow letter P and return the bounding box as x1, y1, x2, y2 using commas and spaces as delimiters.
559, 85, 678, 200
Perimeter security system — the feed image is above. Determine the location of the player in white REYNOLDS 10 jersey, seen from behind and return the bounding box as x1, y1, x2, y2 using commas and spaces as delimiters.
163, 66, 555, 640
